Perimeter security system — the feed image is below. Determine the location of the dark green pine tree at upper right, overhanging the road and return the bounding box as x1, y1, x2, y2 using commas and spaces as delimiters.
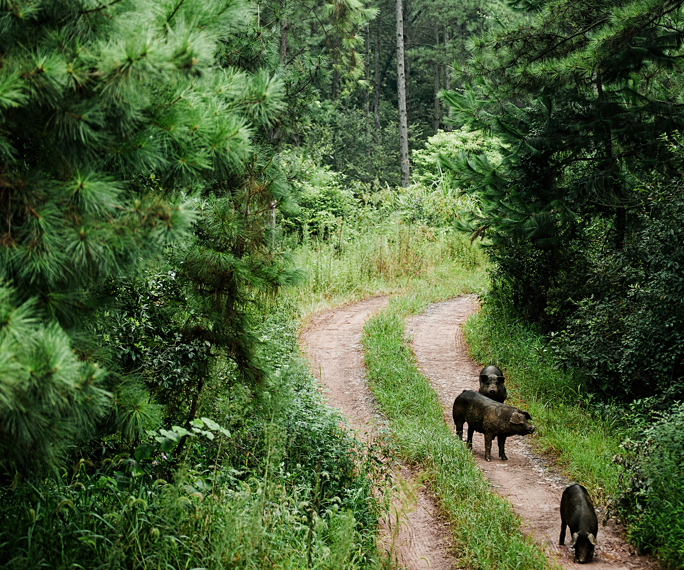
446, 0, 684, 320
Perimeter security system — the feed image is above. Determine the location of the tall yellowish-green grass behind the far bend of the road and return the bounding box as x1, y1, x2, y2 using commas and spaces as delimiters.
284, 219, 487, 314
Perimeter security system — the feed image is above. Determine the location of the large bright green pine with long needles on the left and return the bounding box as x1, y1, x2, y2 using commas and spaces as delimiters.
0, 0, 280, 473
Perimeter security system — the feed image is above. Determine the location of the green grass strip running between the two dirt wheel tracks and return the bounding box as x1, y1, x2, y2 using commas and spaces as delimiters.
362, 292, 550, 570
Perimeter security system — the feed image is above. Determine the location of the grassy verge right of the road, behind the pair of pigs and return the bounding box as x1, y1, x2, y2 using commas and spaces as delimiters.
465, 303, 622, 505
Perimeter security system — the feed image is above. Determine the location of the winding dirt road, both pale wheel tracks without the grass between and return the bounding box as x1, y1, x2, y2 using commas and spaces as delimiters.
300, 296, 655, 570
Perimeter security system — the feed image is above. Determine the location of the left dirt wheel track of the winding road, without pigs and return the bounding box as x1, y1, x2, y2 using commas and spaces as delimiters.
300, 297, 456, 570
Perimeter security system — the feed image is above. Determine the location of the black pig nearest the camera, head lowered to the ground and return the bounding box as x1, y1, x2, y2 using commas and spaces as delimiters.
558, 485, 598, 564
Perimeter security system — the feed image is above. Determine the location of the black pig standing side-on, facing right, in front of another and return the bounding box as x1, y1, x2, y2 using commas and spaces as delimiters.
453, 390, 534, 461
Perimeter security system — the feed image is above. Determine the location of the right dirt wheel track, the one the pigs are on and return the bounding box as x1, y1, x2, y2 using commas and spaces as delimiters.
407, 296, 657, 570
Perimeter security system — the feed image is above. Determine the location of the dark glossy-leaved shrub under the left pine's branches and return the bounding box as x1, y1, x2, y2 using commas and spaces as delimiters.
91, 267, 211, 431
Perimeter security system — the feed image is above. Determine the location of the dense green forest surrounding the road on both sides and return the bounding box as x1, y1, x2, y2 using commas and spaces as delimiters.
0, 0, 684, 569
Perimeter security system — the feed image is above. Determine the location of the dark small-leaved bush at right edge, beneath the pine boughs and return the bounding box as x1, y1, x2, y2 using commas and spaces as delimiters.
551, 177, 684, 400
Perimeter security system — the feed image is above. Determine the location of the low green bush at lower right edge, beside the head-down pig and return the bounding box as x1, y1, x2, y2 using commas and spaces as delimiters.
612, 404, 684, 568
